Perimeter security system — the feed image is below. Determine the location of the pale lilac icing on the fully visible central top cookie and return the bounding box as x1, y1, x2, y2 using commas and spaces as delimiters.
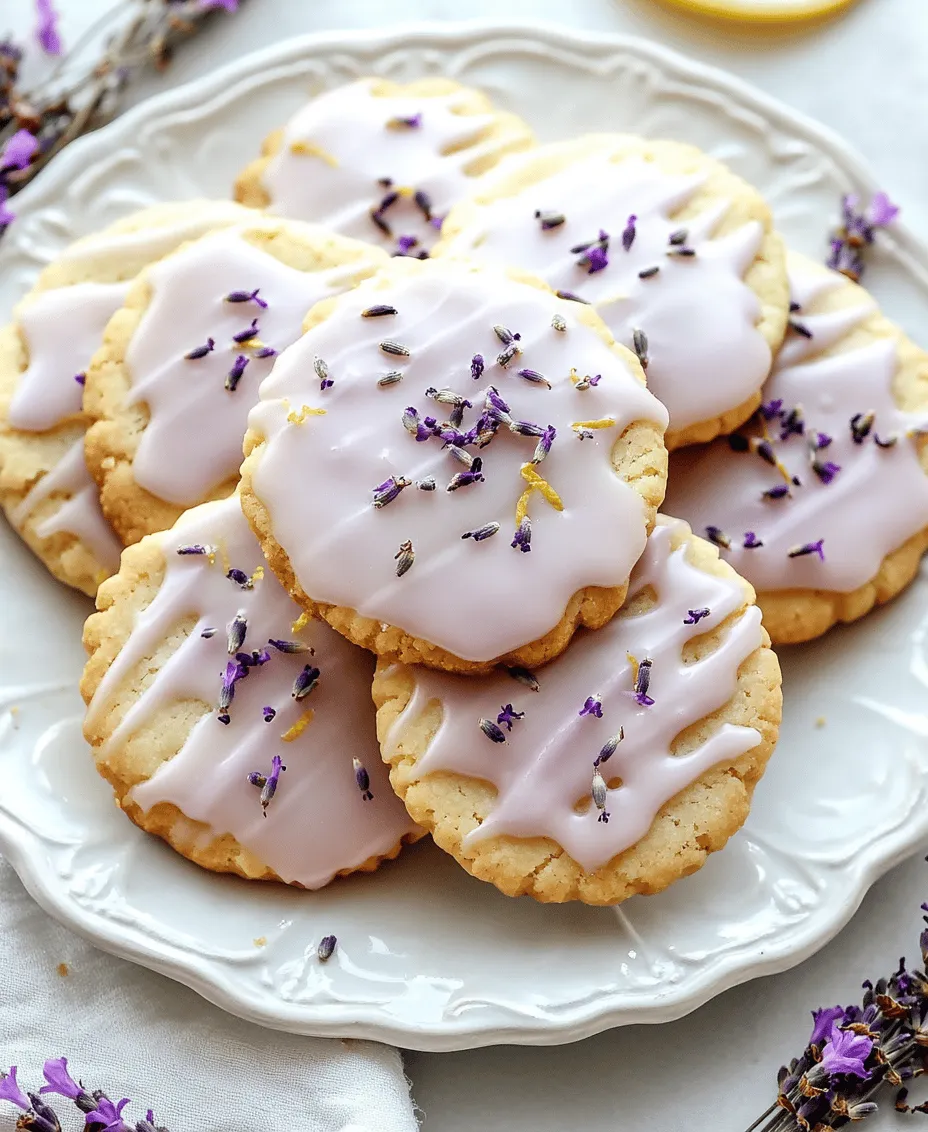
249, 261, 667, 661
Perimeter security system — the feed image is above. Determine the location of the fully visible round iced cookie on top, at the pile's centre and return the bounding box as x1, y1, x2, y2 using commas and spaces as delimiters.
242, 259, 667, 672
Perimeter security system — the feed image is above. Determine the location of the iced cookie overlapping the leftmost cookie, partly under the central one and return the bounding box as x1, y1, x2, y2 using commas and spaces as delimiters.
84, 213, 387, 544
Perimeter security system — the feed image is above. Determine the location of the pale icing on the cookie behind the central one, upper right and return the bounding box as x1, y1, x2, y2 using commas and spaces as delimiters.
440, 150, 771, 432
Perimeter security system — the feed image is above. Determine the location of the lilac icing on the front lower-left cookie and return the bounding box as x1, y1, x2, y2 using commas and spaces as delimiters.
87, 496, 415, 889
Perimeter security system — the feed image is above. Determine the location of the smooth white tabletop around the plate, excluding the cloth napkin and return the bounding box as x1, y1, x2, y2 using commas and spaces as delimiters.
10, 0, 928, 1132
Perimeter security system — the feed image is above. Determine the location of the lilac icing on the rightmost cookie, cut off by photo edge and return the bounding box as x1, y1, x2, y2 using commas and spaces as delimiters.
667, 256, 928, 593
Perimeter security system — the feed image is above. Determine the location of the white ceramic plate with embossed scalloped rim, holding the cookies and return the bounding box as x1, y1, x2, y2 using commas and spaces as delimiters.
0, 25, 928, 1049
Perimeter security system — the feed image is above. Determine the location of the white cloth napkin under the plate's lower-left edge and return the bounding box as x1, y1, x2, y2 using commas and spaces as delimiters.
0, 860, 416, 1132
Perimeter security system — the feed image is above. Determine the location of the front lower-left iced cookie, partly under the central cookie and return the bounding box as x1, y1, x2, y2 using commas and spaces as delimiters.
81, 496, 418, 889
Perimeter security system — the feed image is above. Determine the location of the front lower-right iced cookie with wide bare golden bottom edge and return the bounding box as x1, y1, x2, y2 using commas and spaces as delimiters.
373, 518, 781, 904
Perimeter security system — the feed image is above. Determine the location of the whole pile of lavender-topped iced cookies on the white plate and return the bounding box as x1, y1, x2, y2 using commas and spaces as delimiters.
0, 79, 928, 903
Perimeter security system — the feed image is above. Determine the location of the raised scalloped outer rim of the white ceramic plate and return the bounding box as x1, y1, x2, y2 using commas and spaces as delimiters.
0, 20, 928, 1052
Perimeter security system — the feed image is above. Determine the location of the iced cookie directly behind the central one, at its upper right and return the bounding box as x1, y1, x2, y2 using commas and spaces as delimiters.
436, 135, 788, 448
